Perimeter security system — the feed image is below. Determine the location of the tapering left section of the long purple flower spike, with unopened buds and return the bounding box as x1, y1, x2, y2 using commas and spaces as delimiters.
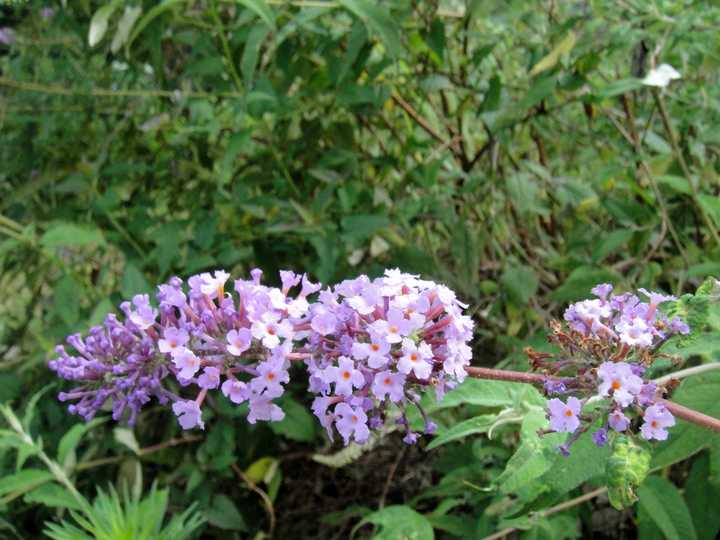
49, 270, 320, 429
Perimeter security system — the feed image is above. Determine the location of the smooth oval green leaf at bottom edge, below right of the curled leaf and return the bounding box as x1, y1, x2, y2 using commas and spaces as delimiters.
638, 476, 697, 540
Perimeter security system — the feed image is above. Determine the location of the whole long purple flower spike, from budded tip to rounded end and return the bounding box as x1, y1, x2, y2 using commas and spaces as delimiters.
49, 270, 473, 444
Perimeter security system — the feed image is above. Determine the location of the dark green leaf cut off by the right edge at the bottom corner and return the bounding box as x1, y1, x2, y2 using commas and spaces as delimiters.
684, 452, 720, 540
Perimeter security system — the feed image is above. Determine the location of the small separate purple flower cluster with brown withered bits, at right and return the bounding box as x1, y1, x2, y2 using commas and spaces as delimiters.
530, 284, 690, 453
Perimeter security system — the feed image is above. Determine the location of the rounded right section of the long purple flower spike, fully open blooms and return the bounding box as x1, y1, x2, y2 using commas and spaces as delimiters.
306, 270, 473, 444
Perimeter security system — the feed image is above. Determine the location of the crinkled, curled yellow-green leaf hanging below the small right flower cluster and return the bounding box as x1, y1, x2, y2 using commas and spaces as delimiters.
605, 435, 650, 510
